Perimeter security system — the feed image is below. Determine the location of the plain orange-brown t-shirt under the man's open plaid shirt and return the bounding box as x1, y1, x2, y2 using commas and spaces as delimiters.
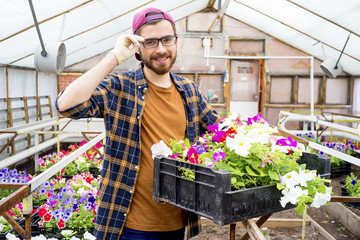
125, 81, 186, 231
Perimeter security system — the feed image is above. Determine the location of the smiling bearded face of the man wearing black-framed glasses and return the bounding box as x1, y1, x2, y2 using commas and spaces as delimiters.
139, 20, 176, 75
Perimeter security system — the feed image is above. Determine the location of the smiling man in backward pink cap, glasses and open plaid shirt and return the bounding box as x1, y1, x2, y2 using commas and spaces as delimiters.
56, 8, 218, 239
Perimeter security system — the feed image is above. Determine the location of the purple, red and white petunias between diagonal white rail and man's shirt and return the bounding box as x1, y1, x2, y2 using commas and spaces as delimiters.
37, 173, 99, 236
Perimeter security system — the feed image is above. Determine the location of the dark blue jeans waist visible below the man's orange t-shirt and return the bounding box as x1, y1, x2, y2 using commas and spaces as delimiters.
120, 227, 185, 240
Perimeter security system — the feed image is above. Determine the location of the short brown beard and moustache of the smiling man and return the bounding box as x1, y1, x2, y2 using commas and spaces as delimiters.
139, 51, 177, 75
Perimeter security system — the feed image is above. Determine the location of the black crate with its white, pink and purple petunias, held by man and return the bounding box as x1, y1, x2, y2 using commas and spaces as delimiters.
152, 114, 331, 224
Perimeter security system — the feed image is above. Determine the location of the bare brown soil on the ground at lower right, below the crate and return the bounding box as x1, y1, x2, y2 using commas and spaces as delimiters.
192, 165, 360, 240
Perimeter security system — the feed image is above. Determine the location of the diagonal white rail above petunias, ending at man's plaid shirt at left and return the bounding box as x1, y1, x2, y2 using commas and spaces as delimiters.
28, 133, 105, 191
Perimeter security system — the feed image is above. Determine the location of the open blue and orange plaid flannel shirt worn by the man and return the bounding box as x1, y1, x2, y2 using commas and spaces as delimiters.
55, 64, 219, 239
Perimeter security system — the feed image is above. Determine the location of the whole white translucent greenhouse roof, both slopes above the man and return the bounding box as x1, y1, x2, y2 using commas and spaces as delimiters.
0, 0, 360, 75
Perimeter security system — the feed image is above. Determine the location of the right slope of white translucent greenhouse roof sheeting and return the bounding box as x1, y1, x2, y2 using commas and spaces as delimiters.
226, 0, 360, 75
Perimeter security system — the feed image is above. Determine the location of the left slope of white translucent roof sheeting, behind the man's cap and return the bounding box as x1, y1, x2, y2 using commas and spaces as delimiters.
0, 0, 208, 67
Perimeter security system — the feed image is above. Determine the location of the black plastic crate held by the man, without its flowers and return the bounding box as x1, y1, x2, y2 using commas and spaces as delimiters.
153, 153, 330, 225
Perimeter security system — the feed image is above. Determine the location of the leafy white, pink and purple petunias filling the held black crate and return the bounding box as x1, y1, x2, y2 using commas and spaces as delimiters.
151, 114, 331, 214
